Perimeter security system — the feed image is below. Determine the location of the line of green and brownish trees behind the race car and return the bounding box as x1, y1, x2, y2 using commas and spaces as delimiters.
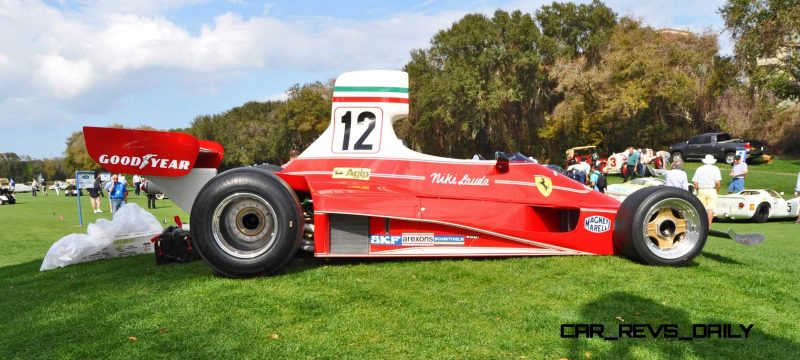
47, 0, 800, 174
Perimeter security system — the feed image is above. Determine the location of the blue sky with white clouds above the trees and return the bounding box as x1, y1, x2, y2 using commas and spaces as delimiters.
0, 0, 731, 158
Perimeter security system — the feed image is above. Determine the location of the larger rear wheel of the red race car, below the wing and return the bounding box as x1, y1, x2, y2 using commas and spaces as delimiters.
191, 168, 303, 277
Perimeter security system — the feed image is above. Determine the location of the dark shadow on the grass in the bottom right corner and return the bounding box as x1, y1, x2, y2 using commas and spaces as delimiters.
563, 292, 800, 359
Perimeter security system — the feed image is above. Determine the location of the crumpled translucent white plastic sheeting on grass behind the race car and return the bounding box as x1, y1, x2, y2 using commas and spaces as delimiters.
39, 203, 163, 271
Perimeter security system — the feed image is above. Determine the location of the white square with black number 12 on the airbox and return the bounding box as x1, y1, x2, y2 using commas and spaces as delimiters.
332, 108, 383, 153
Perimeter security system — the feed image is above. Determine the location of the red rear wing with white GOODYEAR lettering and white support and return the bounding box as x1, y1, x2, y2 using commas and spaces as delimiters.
83, 126, 225, 213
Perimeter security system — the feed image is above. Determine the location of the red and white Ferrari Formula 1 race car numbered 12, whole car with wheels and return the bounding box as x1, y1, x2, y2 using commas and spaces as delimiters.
84, 71, 708, 277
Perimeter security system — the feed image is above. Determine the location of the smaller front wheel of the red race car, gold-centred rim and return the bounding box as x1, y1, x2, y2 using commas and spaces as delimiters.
614, 186, 708, 266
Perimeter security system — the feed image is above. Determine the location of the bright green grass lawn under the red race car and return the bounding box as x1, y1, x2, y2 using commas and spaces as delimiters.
0, 161, 800, 359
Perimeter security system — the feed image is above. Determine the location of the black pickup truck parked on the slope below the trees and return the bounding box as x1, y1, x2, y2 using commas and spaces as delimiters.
669, 133, 765, 164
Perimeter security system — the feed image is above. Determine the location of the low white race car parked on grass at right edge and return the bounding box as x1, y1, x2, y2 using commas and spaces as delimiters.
714, 189, 800, 222
